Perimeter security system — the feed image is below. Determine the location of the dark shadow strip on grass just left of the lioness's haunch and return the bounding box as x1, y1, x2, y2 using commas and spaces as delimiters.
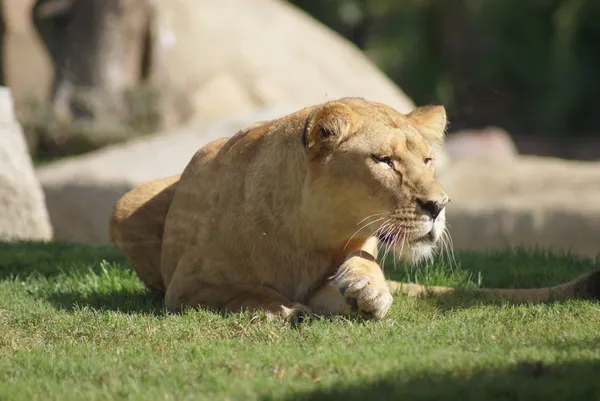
46, 290, 167, 316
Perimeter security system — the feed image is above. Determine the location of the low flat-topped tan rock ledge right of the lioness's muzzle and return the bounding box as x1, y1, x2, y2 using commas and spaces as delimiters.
441, 156, 600, 256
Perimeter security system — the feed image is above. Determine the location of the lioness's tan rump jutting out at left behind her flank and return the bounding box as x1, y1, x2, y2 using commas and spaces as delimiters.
109, 175, 180, 292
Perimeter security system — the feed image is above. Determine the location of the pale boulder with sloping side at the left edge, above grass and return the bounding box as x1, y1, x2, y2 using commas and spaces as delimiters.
0, 87, 52, 241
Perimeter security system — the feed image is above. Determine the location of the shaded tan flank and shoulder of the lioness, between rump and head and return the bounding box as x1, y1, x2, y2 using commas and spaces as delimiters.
162, 125, 343, 303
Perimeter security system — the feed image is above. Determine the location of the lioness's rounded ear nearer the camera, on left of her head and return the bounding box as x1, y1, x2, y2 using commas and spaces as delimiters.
302, 102, 357, 155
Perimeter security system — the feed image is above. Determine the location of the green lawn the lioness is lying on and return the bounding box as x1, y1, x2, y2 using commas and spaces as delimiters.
0, 239, 600, 401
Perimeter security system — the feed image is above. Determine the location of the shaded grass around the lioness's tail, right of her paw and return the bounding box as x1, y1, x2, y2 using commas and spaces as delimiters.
386, 248, 600, 310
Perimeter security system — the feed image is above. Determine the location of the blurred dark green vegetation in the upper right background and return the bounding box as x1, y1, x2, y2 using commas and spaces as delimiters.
289, 0, 600, 137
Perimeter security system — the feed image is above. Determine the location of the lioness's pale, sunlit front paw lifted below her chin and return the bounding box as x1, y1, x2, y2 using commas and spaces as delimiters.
328, 252, 393, 319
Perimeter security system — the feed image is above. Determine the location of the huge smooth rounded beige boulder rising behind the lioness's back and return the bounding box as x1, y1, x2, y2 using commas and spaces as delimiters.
150, 0, 413, 126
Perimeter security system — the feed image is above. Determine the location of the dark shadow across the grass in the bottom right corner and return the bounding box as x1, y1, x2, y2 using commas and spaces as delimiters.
276, 360, 600, 401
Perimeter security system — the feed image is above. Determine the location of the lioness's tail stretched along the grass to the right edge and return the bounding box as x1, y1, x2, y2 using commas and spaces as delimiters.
388, 270, 600, 302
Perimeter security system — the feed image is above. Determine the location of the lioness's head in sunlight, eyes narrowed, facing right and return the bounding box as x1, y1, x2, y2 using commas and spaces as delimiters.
303, 98, 450, 261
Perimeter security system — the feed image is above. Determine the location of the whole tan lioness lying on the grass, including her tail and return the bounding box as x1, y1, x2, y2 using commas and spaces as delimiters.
110, 98, 600, 320
